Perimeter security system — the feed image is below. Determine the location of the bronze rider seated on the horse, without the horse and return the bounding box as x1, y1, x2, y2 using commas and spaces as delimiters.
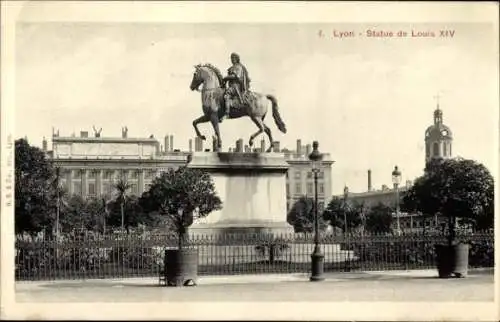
220, 53, 250, 121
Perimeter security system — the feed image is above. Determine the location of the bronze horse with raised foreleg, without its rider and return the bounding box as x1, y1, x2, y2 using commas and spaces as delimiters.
190, 64, 286, 152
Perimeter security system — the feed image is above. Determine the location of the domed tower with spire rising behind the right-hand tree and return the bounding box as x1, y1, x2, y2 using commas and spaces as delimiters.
425, 101, 453, 163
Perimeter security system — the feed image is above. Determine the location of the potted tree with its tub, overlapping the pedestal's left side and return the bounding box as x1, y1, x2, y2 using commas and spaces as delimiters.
141, 166, 222, 286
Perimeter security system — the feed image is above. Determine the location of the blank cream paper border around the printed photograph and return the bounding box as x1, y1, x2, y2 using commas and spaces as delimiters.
1, 1, 499, 320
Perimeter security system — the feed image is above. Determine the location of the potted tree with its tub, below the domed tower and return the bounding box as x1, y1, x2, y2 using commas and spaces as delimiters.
403, 158, 494, 278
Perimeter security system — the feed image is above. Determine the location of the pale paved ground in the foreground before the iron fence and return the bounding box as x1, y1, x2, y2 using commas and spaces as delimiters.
16, 269, 494, 303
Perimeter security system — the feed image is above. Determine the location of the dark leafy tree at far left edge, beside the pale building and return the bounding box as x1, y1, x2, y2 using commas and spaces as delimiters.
15, 139, 56, 234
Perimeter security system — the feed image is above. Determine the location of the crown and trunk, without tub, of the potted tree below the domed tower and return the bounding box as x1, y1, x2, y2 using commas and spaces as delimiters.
403, 158, 494, 244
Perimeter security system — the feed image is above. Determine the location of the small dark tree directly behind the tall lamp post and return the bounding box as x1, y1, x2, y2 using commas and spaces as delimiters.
287, 196, 327, 233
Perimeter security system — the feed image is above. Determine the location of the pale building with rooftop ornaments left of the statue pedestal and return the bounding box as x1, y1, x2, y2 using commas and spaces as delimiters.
49, 130, 189, 197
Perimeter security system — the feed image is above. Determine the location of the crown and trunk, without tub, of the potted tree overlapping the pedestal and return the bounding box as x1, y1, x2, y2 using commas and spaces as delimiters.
139, 167, 222, 249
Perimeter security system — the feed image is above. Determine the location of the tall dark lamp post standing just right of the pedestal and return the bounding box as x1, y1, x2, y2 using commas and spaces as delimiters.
309, 141, 325, 281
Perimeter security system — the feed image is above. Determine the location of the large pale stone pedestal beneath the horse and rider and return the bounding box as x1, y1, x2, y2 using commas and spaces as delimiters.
188, 152, 293, 235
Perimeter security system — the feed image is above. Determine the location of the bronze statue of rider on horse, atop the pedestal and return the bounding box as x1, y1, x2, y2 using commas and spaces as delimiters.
190, 53, 286, 152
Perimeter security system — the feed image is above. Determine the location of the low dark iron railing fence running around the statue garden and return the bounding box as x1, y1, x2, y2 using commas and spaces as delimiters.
15, 232, 494, 280
